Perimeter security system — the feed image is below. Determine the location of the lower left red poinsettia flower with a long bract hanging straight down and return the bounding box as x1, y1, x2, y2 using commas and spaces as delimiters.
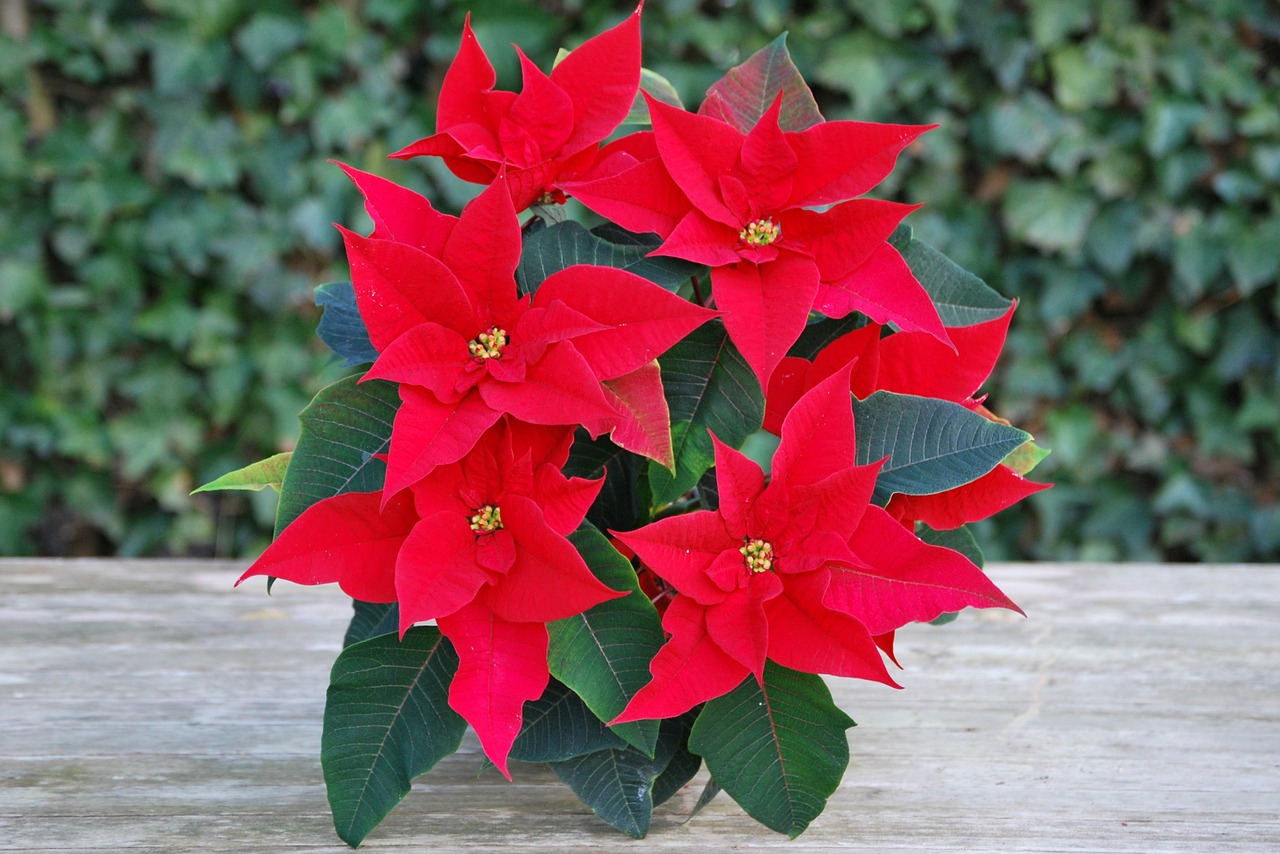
237, 419, 625, 777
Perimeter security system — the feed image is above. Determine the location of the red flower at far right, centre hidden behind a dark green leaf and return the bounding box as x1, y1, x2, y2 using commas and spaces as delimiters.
764, 306, 1048, 530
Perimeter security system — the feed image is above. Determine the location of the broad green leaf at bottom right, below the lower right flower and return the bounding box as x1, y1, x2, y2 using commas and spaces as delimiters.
689, 662, 854, 839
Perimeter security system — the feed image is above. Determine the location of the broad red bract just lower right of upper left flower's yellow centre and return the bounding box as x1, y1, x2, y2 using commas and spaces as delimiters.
479, 342, 617, 434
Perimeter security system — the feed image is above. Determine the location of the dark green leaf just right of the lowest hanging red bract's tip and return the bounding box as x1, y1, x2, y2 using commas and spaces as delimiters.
511, 679, 626, 762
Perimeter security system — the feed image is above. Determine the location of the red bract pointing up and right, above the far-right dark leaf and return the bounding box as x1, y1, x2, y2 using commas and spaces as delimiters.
877, 306, 1014, 403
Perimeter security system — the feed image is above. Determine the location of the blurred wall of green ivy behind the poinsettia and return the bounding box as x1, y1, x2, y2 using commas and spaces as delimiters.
0, 0, 1280, 561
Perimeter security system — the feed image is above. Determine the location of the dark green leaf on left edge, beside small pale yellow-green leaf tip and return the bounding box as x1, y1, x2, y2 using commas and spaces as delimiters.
275, 376, 399, 536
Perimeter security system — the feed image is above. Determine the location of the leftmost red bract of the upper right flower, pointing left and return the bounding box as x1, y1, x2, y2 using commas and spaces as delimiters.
561, 156, 692, 237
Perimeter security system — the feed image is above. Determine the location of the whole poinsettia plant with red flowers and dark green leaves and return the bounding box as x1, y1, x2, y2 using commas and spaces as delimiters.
207, 9, 1044, 845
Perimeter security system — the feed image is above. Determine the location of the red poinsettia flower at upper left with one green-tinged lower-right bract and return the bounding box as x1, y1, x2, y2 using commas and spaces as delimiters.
342, 168, 716, 497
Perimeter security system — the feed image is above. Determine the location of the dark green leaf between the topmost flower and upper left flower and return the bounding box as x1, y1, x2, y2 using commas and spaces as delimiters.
516, 222, 705, 293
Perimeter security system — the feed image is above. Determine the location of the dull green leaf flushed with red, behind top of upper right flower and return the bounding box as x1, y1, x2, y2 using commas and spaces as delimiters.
698, 33, 823, 133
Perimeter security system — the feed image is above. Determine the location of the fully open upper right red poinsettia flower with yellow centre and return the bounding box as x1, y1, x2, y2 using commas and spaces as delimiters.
566, 96, 947, 388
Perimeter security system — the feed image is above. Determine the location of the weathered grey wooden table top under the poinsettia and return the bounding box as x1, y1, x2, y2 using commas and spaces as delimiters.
0, 560, 1280, 854
